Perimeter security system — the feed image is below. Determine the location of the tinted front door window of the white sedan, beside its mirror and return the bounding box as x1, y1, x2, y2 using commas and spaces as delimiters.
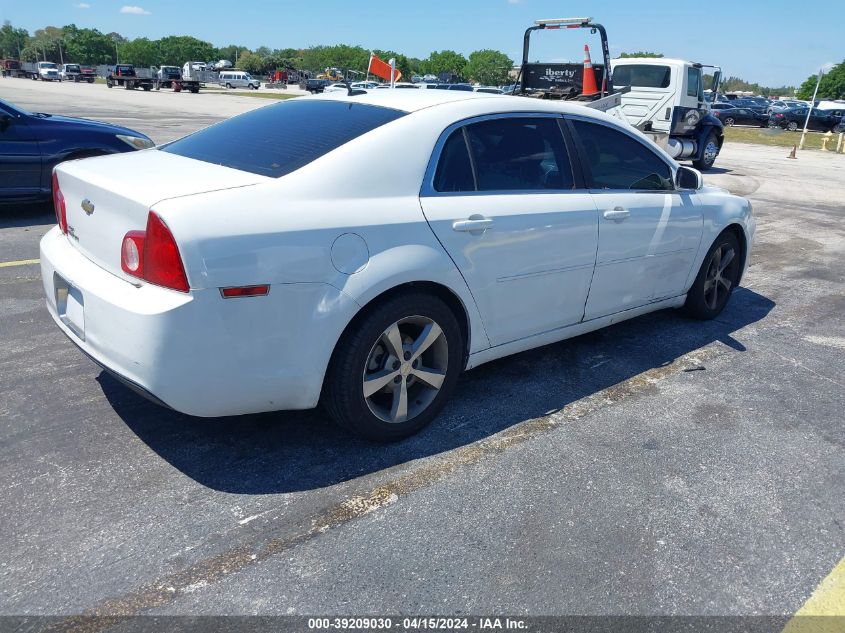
572, 120, 675, 191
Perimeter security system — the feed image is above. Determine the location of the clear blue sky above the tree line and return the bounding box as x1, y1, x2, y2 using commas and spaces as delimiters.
0, 0, 845, 86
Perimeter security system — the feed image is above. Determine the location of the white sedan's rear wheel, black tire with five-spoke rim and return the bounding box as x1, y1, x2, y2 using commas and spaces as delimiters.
323, 292, 464, 442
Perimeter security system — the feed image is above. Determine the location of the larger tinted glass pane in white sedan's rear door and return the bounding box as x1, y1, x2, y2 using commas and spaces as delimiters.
467, 118, 574, 191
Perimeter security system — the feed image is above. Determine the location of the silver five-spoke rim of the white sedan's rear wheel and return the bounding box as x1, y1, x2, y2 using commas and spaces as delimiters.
362, 316, 449, 423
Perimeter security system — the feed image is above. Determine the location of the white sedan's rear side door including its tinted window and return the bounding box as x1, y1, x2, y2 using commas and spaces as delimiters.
420, 114, 598, 345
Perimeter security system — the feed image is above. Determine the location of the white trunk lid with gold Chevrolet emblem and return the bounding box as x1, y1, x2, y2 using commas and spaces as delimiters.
56, 150, 271, 281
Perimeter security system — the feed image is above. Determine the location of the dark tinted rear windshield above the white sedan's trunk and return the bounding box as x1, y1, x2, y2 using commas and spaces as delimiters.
161, 99, 405, 178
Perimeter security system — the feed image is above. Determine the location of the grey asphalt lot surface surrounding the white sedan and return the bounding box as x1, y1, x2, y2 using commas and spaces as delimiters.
0, 80, 845, 617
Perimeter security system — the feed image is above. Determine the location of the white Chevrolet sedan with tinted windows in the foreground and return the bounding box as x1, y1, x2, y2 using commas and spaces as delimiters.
41, 90, 755, 440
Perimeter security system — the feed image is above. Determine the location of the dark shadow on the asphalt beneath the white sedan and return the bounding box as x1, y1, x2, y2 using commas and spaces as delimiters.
97, 288, 775, 494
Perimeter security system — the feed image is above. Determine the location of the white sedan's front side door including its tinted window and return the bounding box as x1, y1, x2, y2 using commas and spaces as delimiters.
570, 117, 702, 319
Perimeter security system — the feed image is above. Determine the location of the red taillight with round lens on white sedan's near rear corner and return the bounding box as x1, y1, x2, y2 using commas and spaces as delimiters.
120, 211, 188, 292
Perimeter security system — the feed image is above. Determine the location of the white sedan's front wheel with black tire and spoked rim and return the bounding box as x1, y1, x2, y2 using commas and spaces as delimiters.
683, 231, 742, 320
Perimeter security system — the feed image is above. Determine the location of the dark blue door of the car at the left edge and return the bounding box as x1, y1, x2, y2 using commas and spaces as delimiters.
0, 104, 41, 198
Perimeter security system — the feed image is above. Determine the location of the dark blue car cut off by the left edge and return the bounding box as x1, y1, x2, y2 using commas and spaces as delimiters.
0, 100, 153, 202
